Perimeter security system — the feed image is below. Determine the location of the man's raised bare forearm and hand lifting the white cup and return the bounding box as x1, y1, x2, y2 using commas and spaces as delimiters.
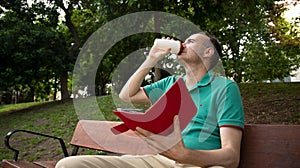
119, 42, 170, 102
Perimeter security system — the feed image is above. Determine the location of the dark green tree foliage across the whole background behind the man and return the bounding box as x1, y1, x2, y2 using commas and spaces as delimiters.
0, 0, 300, 103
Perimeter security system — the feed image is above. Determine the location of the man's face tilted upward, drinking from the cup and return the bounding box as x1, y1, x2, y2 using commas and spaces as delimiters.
177, 34, 209, 64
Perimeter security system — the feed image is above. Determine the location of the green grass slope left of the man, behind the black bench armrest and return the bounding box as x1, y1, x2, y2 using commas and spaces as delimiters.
0, 96, 148, 161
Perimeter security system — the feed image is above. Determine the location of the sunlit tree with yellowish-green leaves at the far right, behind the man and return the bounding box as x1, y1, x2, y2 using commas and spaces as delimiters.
243, 0, 300, 82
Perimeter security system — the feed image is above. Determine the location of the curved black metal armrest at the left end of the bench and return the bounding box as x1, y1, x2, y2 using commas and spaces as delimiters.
4, 130, 69, 161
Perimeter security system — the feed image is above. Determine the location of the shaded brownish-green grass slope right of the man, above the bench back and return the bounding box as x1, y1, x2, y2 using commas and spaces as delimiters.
239, 83, 300, 124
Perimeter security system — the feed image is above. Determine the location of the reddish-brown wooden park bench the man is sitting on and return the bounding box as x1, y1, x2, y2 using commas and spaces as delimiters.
2, 120, 300, 168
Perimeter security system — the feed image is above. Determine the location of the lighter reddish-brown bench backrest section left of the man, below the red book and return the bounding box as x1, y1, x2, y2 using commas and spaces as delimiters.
70, 120, 155, 155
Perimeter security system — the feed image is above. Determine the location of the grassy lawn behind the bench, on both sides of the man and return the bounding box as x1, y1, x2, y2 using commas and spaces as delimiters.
0, 83, 300, 161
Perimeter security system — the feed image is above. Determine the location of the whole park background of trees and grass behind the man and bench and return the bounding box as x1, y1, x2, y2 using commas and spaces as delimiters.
0, 0, 300, 163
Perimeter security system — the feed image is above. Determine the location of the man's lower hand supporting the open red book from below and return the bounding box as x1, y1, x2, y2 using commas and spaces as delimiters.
136, 116, 186, 161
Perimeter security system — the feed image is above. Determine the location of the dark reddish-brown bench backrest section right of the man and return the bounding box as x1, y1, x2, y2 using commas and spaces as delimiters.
240, 124, 300, 168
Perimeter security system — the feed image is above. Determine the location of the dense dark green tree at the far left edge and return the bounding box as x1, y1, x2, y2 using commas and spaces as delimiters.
0, 1, 60, 102
